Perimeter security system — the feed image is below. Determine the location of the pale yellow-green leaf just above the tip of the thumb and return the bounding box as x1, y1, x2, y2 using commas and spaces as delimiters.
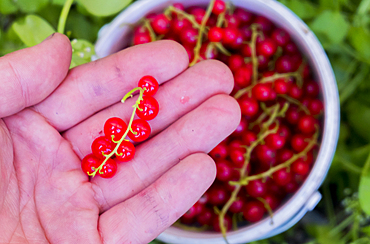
12, 15, 55, 47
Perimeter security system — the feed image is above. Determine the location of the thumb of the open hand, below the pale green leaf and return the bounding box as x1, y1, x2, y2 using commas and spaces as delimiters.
0, 33, 72, 118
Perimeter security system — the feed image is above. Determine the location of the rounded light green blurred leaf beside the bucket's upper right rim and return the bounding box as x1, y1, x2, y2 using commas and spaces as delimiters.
310, 10, 350, 44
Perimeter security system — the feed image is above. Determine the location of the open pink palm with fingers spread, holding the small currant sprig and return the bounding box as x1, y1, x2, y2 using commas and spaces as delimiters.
0, 34, 240, 244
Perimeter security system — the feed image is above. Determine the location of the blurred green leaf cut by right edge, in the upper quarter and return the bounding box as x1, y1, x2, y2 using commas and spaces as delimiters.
348, 27, 370, 60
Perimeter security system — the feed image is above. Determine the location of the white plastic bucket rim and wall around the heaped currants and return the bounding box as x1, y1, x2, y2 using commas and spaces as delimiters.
95, 0, 340, 244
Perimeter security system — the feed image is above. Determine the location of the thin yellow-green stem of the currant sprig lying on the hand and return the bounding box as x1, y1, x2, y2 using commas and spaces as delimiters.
88, 87, 145, 177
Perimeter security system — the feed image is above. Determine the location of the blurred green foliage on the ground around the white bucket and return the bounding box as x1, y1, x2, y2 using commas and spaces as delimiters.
0, 0, 370, 244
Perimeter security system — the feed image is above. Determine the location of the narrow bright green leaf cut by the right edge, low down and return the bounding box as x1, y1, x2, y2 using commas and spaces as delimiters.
358, 150, 370, 215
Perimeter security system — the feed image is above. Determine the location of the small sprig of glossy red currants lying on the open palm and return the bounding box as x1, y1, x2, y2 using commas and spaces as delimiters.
81, 76, 159, 178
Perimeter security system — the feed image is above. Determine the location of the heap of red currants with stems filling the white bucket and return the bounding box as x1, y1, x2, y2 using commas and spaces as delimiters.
129, 0, 324, 234
